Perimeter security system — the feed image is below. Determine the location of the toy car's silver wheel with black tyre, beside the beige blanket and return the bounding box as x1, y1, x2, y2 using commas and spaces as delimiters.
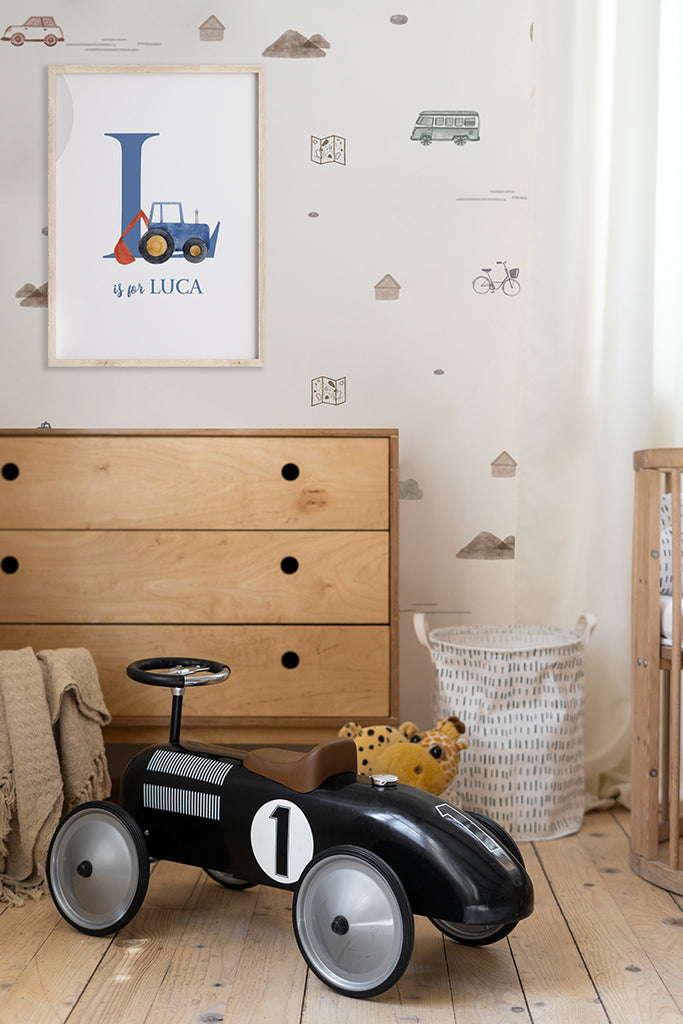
47, 801, 150, 935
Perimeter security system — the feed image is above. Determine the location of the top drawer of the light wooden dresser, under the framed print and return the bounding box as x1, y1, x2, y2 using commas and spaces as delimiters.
0, 431, 389, 529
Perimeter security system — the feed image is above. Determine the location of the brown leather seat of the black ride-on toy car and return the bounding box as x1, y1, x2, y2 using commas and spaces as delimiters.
243, 739, 357, 793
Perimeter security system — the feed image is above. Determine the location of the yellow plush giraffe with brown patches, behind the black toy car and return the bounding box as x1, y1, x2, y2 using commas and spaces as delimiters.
374, 715, 467, 796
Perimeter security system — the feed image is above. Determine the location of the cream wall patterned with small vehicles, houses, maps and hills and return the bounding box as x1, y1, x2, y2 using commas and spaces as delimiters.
0, 0, 532, 724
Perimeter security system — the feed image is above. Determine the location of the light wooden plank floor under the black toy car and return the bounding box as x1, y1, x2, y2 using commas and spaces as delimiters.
0, 810, 683, 1024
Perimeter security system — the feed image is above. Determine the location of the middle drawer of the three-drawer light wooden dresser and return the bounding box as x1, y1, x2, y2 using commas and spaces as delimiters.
0, 530, 389, 623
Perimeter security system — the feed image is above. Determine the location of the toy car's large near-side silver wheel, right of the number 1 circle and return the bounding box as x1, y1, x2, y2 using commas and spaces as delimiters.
292, 846, 415, 998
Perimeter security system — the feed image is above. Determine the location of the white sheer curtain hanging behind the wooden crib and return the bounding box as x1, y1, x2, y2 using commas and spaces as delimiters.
515, 0, 683, 777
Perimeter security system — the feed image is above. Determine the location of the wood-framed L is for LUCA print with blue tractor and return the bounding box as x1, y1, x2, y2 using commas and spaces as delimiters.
48, 66, 263, 367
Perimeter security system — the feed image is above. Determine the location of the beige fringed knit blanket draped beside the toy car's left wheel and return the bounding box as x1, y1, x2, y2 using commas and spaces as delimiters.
0, 647, 112, 903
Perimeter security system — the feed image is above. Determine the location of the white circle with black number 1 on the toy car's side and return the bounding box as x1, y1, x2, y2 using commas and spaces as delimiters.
251, 800, 313, 883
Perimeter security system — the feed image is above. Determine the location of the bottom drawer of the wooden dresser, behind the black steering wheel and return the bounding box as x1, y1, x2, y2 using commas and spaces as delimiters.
0, 625, 390, 728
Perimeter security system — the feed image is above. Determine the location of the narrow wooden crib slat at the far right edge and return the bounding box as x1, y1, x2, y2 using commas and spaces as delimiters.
668, 472, 681, 871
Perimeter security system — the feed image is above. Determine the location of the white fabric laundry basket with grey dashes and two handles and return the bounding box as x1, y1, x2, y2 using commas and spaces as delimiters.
414, 614, 595, 840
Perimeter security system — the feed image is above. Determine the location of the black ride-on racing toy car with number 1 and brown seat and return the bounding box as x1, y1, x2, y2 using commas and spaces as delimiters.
47, 657, 533, 997
